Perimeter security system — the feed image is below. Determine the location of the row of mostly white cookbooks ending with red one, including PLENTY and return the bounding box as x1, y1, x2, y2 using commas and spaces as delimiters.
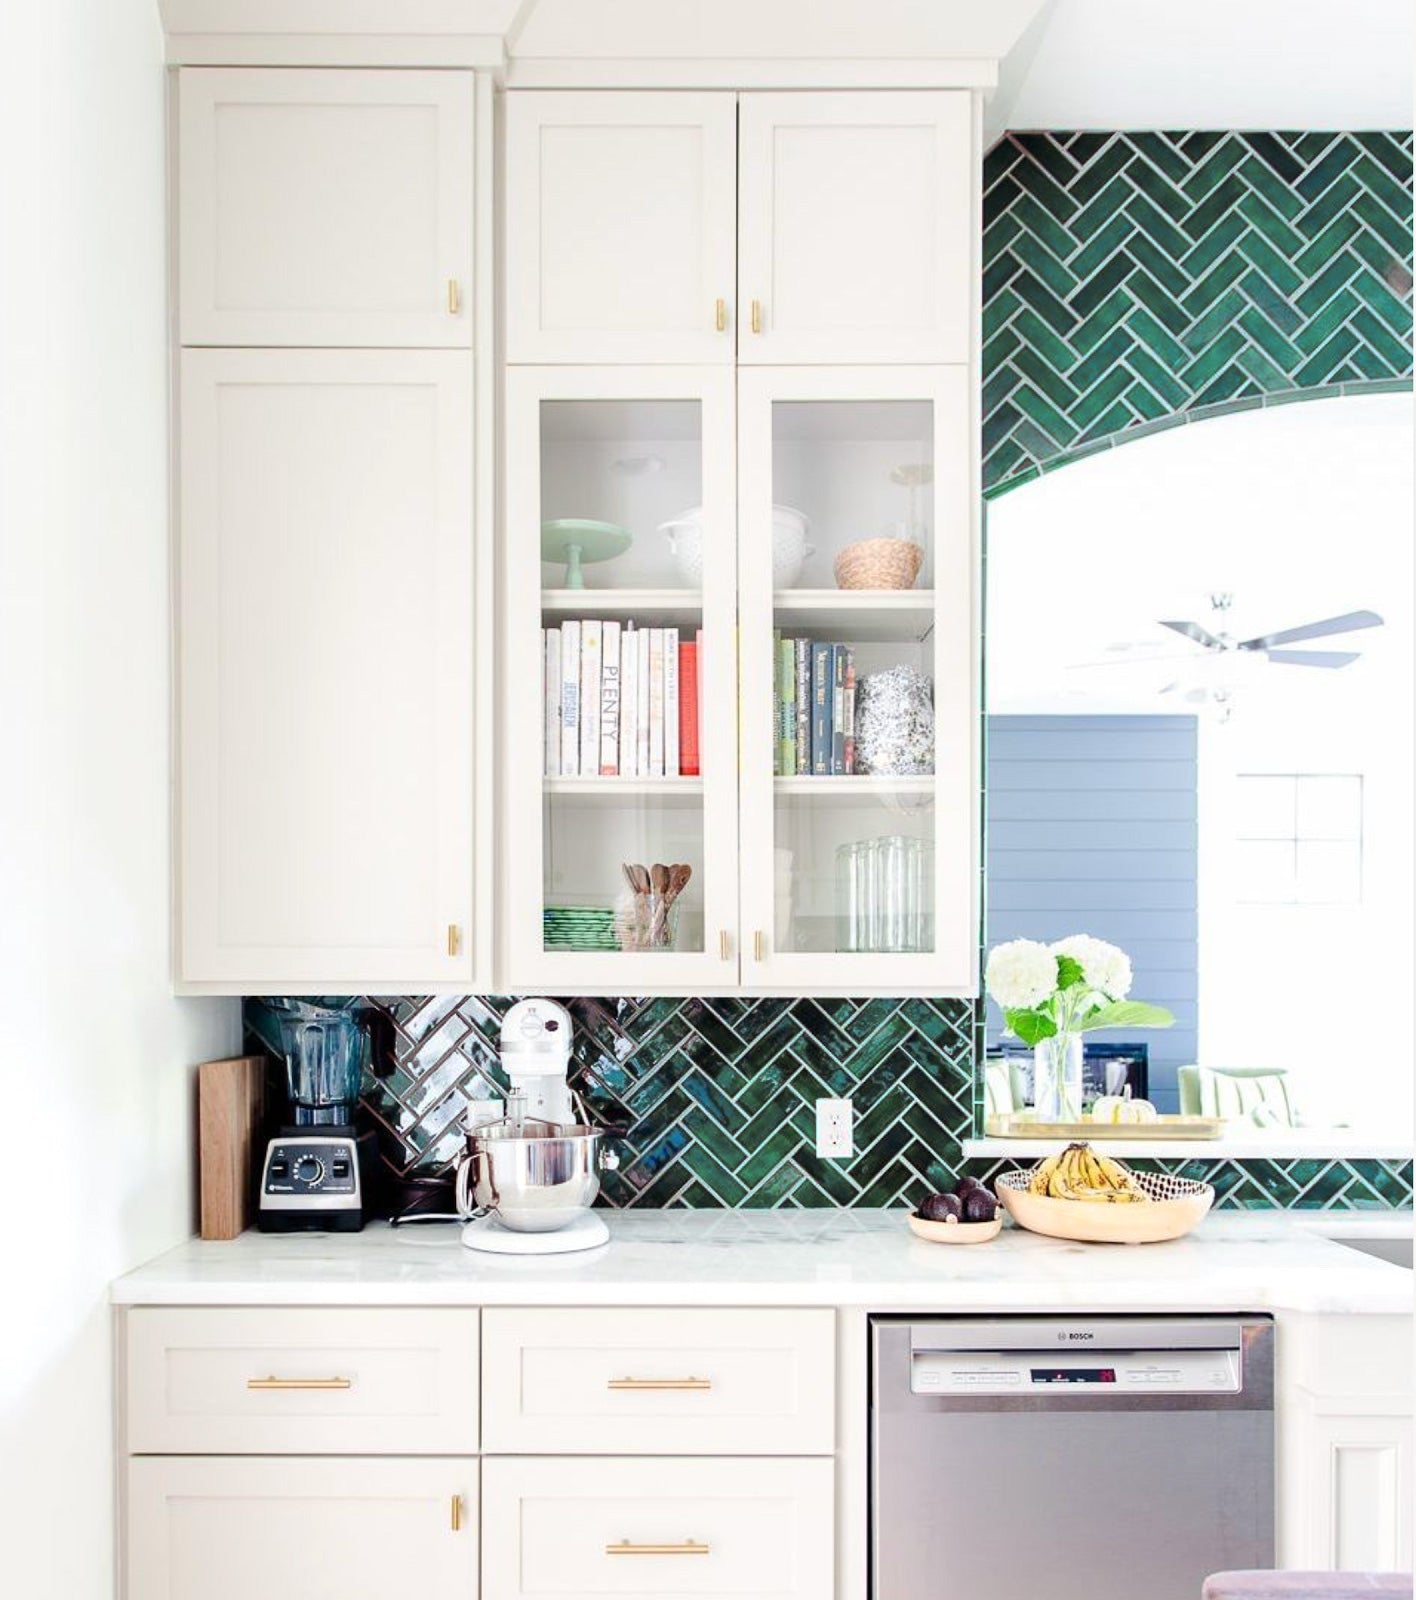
541, 619, 702, 778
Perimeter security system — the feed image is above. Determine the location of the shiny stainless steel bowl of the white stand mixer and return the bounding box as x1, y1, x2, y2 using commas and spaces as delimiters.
458, 1123, 600, 1234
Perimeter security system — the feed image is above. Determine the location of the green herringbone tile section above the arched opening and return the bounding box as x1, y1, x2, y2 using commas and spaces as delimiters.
984, 133, 1411, 494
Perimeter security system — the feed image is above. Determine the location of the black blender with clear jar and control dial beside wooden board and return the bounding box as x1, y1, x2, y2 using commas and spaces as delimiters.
256, 1000, 363, 1234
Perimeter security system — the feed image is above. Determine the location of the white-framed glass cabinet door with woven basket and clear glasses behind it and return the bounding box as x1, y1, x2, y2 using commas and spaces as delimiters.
738, 366, 979, 995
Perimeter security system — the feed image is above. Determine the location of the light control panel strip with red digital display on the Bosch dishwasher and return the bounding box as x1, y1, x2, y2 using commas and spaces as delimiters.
910, 1350, 1240, 1395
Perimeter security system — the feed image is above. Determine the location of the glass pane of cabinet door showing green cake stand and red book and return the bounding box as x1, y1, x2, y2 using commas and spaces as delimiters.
528, 400, 707, 954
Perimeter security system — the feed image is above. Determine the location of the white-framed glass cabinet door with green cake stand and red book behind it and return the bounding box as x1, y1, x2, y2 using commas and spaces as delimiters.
499, 366, 739, 994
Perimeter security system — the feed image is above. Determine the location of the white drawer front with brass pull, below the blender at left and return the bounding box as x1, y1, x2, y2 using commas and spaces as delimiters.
126, 1307, 478, 1456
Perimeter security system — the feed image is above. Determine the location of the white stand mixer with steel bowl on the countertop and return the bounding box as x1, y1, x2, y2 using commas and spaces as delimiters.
458, 1000, 616, 1256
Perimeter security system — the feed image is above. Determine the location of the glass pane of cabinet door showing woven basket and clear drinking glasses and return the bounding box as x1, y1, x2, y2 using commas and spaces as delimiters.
768, 400, 936, 954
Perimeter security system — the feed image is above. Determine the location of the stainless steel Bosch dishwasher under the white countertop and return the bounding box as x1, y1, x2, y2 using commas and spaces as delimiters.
870, 1317, 1274, 1600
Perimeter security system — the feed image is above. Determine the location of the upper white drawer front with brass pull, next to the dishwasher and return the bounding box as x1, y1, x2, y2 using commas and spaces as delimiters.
482, 1310, 835, 1456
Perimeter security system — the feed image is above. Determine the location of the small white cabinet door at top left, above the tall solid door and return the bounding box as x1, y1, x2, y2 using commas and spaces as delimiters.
176, 67, 475, 347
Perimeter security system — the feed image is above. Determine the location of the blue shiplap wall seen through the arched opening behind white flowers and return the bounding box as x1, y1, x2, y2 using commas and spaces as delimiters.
987, 717, 1198, 1110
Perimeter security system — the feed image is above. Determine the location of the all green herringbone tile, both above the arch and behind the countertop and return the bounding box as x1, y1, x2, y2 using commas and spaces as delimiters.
246, 133, 1411, 1210
